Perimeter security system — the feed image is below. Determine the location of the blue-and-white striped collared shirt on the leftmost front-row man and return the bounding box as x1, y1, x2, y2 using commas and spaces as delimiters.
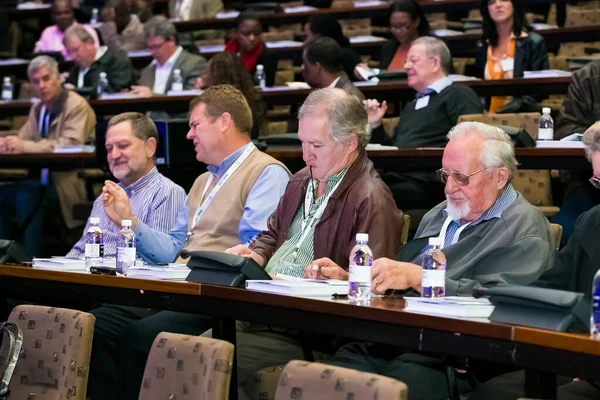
67, 167, 185, 261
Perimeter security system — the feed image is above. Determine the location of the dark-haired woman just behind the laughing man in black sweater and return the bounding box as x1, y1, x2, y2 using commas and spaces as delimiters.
379, 0, 430, 71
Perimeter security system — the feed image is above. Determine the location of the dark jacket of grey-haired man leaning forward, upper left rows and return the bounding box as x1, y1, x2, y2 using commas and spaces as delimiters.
65, 50, 135, 95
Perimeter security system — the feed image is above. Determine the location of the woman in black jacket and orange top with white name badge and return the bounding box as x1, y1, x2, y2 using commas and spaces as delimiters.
475, 0, 548, 113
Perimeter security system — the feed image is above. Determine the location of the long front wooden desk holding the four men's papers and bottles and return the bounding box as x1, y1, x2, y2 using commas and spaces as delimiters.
0, 266, 600, 400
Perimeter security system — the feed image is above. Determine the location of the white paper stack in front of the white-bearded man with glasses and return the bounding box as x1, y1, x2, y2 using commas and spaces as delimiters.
404, 296, 494, 318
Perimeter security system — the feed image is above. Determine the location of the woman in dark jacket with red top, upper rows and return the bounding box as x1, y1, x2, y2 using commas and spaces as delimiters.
225, 12, 277, 86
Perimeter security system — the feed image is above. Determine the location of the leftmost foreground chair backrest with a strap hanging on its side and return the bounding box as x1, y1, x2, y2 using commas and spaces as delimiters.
8, 305, 96, 400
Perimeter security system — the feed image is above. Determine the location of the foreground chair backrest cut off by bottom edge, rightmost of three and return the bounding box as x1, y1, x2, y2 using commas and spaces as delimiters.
275, 360, 408, 400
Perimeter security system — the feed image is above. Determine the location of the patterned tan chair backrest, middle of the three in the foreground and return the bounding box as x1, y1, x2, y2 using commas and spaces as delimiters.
139, 332, 233, 400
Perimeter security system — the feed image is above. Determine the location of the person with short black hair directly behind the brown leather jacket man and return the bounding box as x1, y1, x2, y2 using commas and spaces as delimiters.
302, 36, 365, 100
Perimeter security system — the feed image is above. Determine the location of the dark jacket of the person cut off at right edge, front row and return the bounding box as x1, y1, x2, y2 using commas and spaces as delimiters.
534, 206, 600, 301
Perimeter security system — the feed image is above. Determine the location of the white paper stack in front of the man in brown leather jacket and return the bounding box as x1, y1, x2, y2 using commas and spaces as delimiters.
246, 279, 348, 296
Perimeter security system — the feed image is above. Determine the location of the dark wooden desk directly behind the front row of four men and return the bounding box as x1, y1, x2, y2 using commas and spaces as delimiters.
0, 144, 591, 171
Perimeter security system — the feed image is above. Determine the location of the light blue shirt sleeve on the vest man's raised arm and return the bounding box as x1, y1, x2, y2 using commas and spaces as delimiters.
135, 204, 188, 264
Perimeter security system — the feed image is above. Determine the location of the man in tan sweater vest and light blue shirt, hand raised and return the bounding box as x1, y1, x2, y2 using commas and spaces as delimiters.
90, 85, 289, 399
